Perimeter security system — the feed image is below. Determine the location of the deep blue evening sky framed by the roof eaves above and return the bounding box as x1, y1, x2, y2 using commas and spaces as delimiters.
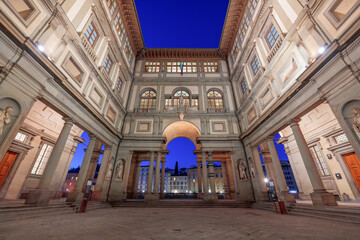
135, 0, 229, 48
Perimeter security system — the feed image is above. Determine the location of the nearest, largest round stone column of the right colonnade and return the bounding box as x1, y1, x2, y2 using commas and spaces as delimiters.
290, 119, 337, 206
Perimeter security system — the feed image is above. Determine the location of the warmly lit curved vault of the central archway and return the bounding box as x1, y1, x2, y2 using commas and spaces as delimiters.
163, 121, 201, 150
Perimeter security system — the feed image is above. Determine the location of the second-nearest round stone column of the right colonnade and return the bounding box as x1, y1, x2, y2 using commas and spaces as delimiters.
266, 137, 296, 203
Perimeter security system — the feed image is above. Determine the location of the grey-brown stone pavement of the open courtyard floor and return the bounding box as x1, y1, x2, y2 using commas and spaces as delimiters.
0, 208, 359, 240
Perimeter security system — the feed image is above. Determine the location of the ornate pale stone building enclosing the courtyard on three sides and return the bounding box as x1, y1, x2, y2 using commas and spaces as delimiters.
0, 0, 360, 206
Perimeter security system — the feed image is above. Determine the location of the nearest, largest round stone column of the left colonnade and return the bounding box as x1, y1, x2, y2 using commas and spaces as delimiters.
25, 118, 74, 205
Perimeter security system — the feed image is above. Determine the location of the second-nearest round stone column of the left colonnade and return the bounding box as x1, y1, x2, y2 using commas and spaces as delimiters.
66, 134, 96, 202
